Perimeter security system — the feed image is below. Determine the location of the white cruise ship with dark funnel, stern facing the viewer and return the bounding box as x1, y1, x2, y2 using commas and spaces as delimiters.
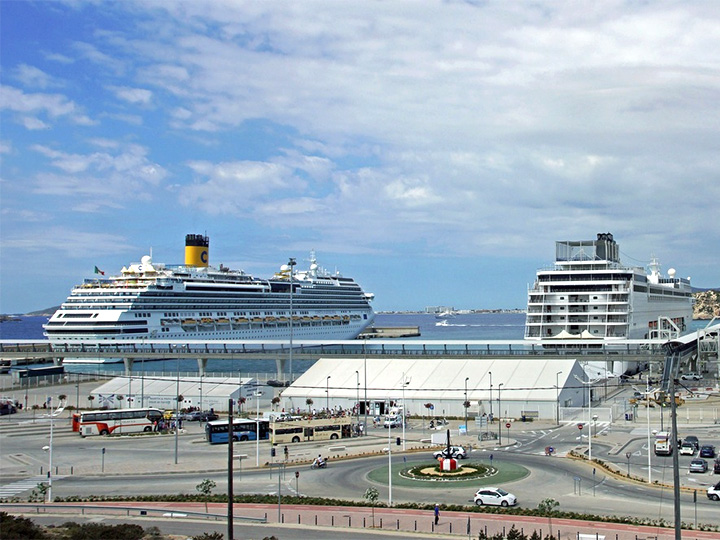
525, 233, 693, 342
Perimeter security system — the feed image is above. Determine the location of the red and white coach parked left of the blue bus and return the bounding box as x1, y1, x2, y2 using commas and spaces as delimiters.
72, 407, 163, 437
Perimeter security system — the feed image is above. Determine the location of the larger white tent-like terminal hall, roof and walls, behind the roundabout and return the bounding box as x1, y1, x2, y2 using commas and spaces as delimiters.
281, 357, 600, 420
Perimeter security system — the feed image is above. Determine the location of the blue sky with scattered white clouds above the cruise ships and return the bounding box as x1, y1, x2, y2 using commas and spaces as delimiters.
0, 0, 720, 313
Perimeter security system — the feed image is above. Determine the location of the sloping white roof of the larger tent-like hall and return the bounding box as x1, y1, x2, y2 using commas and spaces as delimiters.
282, 358, 582, 401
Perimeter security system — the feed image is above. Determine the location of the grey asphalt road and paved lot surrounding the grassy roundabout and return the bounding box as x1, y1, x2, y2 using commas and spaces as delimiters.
0, 414, 720, 525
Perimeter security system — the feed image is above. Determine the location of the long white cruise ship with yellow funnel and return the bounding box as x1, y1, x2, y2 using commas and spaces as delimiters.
44, 234, 375, 358
